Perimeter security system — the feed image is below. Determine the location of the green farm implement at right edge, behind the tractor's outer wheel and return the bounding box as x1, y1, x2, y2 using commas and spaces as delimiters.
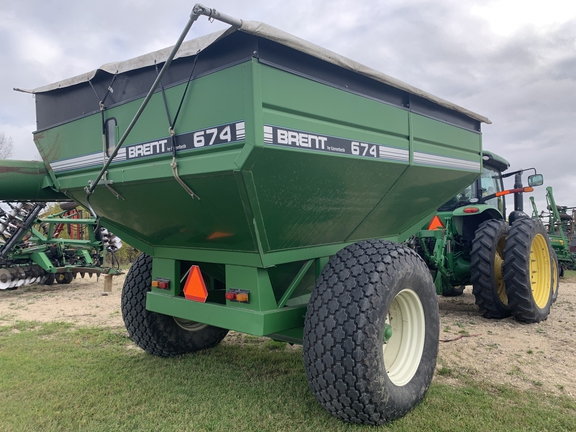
530, 186, 576, 277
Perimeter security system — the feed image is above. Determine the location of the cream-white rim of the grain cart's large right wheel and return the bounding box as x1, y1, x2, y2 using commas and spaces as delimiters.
382, 289, 426, 387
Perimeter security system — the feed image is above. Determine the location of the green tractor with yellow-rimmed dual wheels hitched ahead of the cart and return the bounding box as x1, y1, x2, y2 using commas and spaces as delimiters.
410, 151, 558, 323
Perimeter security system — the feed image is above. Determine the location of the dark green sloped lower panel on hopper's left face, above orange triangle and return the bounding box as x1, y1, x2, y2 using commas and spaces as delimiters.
91, 173, 255, 251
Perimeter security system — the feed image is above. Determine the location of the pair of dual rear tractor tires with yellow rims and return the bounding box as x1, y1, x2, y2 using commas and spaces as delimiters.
470, 218, 558, 323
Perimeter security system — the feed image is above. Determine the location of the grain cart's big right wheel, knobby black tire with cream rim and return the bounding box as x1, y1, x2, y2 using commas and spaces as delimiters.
304, 240, 439, 425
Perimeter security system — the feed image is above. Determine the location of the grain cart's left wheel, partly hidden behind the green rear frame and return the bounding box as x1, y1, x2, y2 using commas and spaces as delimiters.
121, 254, 228, 357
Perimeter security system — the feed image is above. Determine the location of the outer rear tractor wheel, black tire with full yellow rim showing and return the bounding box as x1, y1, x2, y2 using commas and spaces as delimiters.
504, 218, 553, 323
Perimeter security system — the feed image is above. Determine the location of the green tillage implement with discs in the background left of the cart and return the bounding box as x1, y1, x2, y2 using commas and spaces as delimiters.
0, 202, 119, 290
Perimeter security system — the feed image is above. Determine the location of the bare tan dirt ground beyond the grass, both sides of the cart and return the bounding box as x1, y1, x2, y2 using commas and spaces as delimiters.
0, 276, 576, 397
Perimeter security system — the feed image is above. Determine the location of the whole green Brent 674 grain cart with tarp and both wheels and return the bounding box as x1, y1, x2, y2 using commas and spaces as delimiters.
0, 5, 489, 424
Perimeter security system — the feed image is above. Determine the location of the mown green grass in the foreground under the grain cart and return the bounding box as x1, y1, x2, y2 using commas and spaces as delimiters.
0, 322, 576, 432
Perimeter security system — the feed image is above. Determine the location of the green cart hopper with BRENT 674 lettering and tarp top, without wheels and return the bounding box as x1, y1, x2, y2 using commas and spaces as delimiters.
16, 21, 489, 266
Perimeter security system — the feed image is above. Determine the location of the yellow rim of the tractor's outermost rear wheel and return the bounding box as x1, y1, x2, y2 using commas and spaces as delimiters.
530, 234, 552, 309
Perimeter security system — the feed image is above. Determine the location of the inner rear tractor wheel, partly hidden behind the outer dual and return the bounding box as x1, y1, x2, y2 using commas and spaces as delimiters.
470, 219, 511, 319
